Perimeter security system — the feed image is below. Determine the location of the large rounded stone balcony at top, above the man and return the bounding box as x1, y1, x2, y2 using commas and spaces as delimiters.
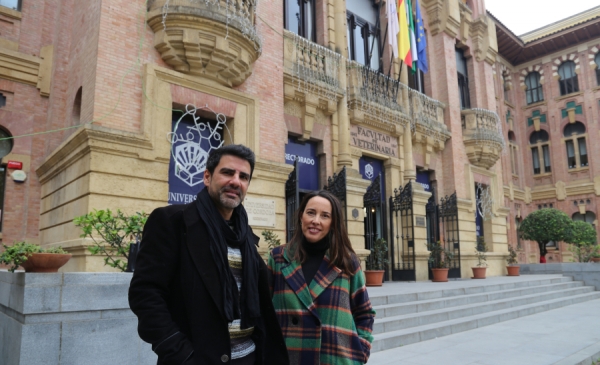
148, 0, 261, 87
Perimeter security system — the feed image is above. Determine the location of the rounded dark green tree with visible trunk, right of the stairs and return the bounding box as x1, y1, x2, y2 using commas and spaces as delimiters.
519, 208, 573, 257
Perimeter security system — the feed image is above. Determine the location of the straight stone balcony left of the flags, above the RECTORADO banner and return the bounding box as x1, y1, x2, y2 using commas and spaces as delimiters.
284, 30, 345, 114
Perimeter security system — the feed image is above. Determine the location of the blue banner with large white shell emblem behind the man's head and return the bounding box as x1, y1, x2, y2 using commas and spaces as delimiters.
168, 113, 224, 204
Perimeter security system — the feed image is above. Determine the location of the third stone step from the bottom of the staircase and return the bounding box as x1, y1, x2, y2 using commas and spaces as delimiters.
373, 281, 583, 319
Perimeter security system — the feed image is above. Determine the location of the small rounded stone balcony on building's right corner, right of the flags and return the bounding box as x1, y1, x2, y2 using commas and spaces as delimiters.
461, 109, 505, 169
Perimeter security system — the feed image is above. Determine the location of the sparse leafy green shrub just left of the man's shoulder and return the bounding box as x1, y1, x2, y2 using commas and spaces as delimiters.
73, 209, 148, 271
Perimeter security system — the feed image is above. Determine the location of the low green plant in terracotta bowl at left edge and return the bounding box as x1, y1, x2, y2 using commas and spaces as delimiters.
0, 242, 71, 272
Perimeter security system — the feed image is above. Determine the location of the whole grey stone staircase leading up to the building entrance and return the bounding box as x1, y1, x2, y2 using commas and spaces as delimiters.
369, 275, 600, 352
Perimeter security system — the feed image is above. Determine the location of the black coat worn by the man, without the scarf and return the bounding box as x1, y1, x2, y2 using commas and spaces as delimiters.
129, 202, 289, 365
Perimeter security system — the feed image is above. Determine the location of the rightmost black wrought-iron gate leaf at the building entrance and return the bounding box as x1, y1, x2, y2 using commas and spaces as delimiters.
438, 192, 460, 278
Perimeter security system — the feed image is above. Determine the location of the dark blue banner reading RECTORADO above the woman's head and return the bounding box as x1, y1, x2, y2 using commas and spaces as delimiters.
285, 137, 319, 191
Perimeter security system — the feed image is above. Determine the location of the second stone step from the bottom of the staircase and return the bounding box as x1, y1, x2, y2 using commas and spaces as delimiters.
373, 286, 594, 334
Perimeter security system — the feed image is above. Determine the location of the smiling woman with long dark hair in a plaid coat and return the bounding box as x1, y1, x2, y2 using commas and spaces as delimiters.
268, 190, 375, 365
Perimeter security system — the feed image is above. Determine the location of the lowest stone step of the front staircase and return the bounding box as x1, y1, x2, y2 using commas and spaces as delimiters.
371, 291, 600, 352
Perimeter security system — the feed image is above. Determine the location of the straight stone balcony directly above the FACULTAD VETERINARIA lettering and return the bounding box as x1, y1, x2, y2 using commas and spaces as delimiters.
347, 61, 410, 129
